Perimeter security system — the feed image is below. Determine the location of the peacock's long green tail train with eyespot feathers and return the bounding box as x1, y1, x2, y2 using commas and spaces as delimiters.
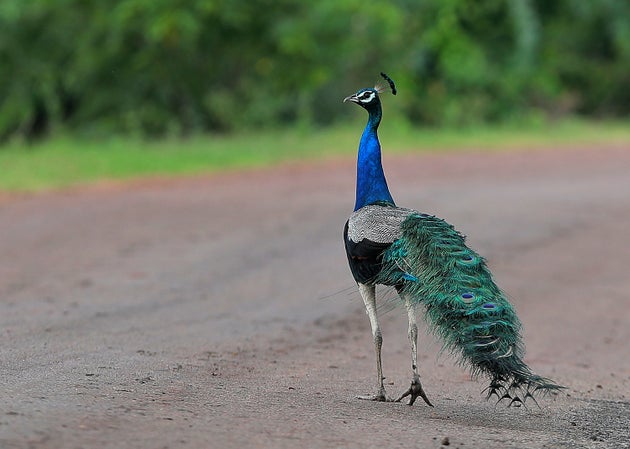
377, 214, 562, 404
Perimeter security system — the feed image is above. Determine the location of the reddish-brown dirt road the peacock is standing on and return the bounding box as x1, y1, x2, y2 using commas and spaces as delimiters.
0, 145, 630, 449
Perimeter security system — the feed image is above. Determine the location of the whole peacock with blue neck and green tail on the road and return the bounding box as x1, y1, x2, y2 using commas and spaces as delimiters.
343, 73, 563, 407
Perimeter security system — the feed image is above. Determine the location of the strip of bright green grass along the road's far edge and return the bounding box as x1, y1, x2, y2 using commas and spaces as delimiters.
0, 121, 630, 192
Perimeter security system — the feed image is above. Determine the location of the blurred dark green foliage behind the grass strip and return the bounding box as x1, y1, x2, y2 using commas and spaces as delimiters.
0, 0, 630, 139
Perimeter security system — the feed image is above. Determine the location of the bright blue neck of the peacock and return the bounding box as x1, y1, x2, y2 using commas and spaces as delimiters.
354, 104, 394, 211
